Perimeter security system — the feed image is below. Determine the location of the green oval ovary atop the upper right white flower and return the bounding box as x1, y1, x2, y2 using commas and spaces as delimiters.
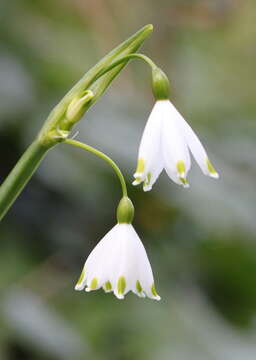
152, 67, 170, 100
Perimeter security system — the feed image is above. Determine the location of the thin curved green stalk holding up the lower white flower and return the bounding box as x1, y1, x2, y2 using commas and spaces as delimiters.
64, 139, 127, 196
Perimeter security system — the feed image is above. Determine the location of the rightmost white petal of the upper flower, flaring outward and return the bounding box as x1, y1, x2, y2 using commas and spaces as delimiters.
167, 102, 219, 178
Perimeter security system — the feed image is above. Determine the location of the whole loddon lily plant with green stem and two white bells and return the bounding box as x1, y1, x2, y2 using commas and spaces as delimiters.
0, 25, 219, 300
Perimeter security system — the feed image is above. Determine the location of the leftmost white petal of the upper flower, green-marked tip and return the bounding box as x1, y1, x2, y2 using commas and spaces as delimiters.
133, 101, 163, 187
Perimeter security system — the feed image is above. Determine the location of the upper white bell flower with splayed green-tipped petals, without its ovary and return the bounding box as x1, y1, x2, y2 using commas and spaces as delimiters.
133, 100, 219, 191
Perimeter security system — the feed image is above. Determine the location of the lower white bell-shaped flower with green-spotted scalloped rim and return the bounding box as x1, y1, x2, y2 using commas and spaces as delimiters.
75, 223, 160, 300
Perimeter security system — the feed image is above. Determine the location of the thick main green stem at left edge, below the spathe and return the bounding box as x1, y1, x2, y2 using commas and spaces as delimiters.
0, 140, 49, 220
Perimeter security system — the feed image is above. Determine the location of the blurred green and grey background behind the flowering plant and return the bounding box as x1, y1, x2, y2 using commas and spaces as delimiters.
0, 0, 256, 360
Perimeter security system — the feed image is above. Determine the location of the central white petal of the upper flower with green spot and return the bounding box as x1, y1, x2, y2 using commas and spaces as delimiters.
162, 100, 191, 187
